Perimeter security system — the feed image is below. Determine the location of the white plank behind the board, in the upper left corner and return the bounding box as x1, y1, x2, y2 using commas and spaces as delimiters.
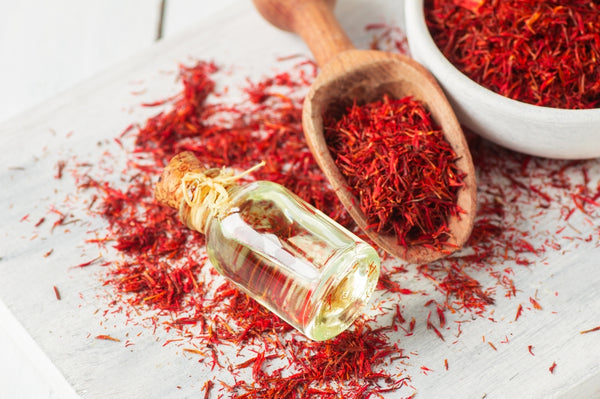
0, 0, 160, 121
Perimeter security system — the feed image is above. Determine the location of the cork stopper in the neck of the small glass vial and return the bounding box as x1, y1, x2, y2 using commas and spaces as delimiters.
154, 151, 204, 209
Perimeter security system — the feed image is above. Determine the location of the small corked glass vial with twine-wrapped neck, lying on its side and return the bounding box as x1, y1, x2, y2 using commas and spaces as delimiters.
155, 152, 380, 341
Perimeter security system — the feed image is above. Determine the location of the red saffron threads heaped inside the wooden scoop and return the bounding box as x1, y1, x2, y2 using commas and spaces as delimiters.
323, 95, 464, 248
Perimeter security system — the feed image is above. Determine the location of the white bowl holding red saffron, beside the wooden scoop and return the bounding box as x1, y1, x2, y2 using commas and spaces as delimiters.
405, 0, 600, 159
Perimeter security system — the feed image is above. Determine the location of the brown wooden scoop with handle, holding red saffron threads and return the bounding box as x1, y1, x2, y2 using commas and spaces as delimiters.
253, 0, 477, 263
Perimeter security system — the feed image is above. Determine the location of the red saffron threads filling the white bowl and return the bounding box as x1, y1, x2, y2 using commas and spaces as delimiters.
424, 0, 600, 109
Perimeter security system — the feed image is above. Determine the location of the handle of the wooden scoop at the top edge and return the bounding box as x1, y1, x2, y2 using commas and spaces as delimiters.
252, 0, 354, 66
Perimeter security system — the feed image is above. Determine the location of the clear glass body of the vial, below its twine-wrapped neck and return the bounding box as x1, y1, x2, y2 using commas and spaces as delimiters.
206, 182, 379, 340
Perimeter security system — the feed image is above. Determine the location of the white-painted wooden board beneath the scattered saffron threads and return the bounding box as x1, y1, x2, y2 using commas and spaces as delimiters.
0, 0, 600, 398
